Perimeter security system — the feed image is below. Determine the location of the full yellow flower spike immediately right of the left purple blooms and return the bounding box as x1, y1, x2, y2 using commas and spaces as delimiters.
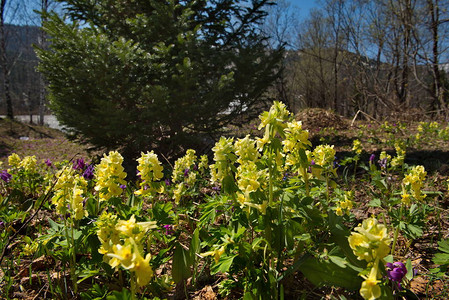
95, 151, 126, 201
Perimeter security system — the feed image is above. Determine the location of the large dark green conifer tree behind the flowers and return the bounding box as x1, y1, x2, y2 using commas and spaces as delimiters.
36, 0, 283, 161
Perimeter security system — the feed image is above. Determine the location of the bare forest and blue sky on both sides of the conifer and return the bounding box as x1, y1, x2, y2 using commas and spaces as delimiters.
0, 0, 449, 122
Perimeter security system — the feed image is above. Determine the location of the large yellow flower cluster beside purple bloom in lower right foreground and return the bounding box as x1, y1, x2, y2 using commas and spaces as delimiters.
348, 217, 391, 300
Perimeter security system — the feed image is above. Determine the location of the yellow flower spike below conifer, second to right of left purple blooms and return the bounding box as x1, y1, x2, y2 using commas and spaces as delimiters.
134, 151, 164, 195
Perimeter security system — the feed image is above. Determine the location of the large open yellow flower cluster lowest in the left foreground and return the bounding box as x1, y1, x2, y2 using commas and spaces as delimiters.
97, 213, 156, 287
